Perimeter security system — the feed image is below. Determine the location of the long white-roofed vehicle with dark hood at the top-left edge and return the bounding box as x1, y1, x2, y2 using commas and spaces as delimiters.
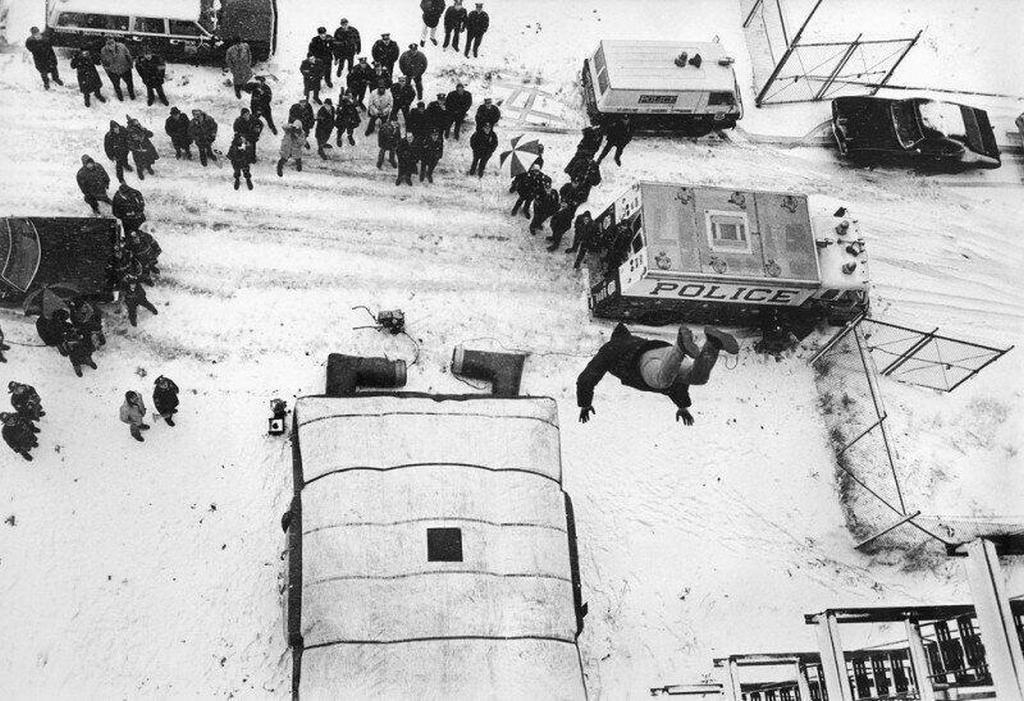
46, 0, 278, 61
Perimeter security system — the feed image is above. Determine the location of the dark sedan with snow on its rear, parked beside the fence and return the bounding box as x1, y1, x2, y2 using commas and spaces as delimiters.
833, 97, 1000, 170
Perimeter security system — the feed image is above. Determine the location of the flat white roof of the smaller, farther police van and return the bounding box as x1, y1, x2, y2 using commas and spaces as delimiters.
600, 40, 735, 92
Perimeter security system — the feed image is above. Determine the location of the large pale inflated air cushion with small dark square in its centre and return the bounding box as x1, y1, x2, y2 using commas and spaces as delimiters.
295, 395, 585, 699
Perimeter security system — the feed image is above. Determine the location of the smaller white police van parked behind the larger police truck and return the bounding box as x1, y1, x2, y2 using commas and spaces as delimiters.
583, 41, 743, 134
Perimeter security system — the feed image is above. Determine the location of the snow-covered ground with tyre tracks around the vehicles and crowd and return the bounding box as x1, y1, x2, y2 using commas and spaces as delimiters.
0, 0, 1024, 699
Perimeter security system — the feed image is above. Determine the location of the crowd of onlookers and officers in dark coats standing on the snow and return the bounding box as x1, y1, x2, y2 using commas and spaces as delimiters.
6, 0, 679, 458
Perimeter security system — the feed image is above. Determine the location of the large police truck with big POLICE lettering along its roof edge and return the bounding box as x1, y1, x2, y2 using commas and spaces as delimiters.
588, 182, 870, 331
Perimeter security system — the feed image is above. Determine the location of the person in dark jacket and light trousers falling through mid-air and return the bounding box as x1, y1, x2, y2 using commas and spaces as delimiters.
577, 323, 738, 426
